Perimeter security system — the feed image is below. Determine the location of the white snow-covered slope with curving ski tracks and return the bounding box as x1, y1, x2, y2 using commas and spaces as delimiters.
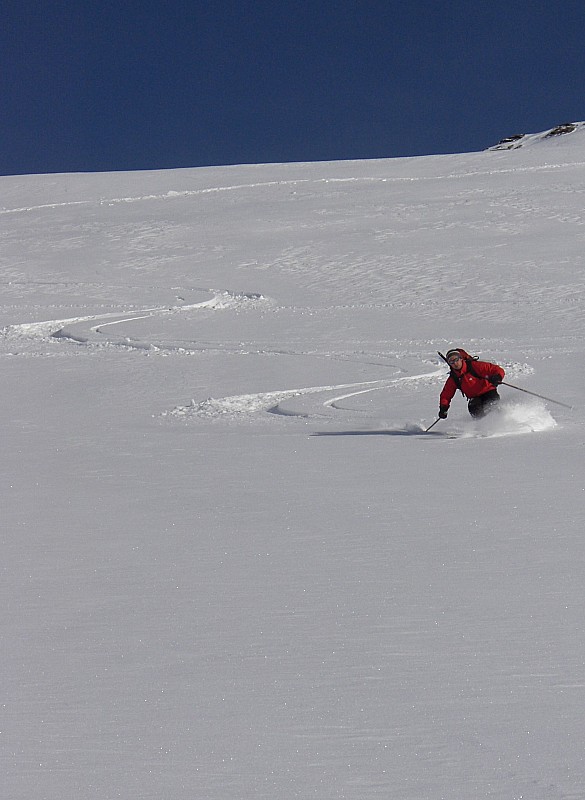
0, 124, 585, 800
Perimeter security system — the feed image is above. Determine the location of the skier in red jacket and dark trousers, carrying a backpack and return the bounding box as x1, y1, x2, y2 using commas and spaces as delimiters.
439, 347, 506, 419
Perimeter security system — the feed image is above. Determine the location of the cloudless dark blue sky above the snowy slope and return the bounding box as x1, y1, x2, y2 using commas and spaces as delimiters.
0, 0, 585, 175
